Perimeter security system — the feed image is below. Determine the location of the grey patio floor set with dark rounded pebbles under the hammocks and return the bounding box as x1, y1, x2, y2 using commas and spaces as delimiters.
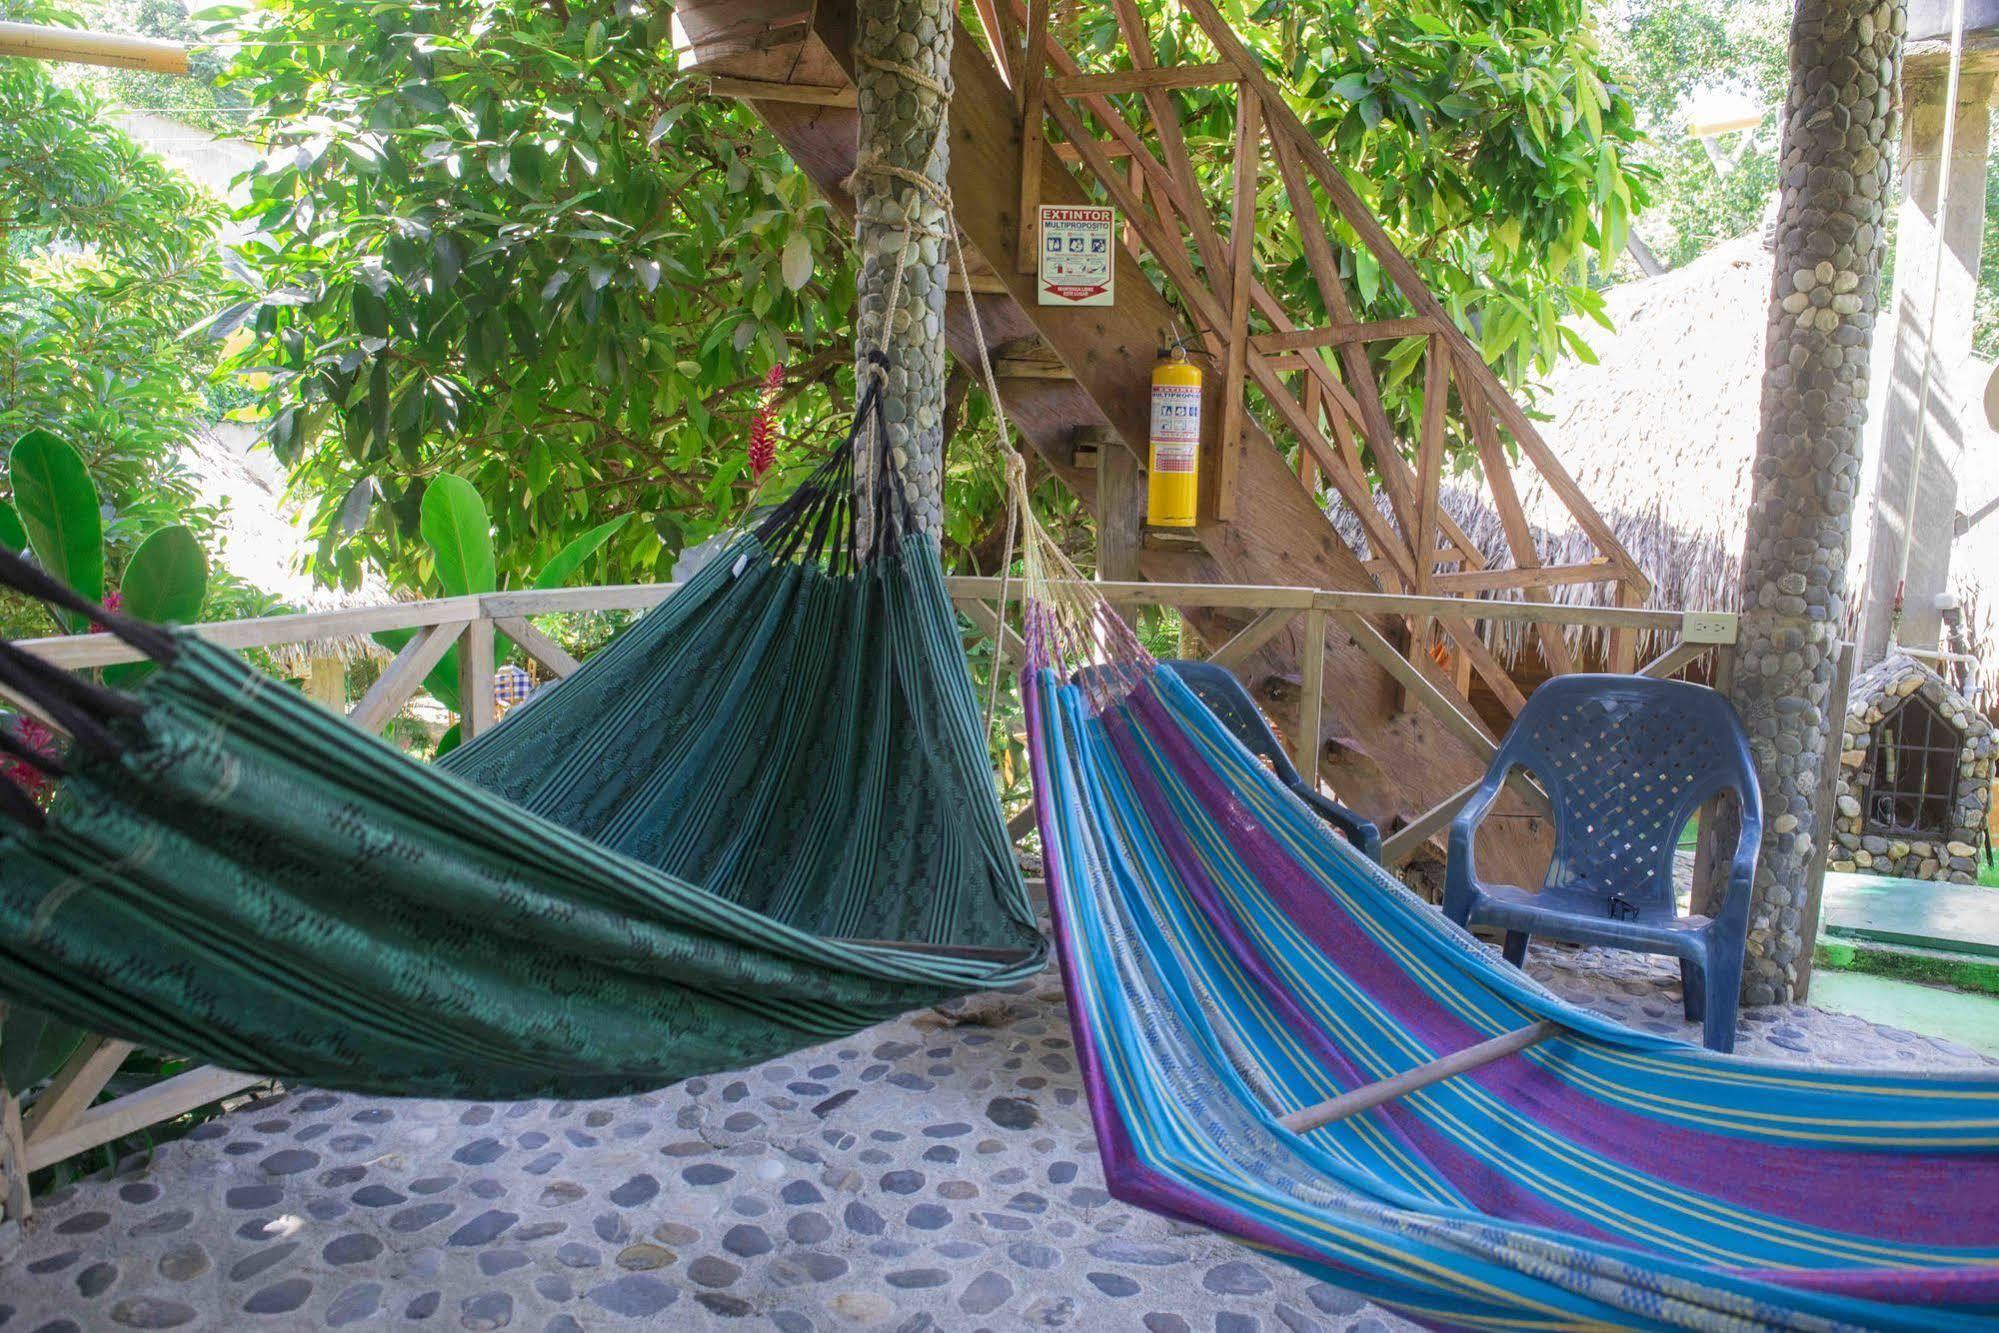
0, 947, 1991, 1333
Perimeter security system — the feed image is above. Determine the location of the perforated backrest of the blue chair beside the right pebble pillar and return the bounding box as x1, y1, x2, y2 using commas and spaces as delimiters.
1493, 673, 1757, 911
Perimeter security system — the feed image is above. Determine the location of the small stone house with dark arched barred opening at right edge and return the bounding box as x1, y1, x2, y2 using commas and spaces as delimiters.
1829, 654, 1993, 883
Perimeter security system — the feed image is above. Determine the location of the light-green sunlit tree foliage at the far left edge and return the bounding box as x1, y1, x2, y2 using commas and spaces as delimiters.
0, 37, 228, 558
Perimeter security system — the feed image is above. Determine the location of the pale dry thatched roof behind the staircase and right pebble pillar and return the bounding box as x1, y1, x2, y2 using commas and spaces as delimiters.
1331, 234, 1999, 703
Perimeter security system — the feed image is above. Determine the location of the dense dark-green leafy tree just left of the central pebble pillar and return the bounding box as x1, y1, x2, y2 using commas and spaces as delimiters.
218, 0, 854, 586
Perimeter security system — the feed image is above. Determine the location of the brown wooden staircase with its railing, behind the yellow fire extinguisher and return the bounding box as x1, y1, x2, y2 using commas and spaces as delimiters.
676, 0, 1649, 883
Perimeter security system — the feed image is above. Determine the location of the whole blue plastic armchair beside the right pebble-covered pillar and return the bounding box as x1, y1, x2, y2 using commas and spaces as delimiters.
1443, 675, 1763, 1051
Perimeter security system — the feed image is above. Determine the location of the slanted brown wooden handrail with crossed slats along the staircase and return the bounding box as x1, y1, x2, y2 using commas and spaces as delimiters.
978, 0, 1651, 713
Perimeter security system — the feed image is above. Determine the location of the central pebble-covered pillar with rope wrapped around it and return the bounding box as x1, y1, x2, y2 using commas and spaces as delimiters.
854, 0, 956, 536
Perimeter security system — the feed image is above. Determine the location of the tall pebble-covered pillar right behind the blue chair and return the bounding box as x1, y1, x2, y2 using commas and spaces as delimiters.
1729, 0, 1907, 1005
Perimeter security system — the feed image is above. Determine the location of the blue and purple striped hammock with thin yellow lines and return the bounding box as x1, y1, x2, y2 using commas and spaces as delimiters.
1021, 639, 1999, 1329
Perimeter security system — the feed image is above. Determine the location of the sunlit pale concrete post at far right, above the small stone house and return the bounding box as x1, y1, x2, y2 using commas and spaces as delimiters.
1855, 52, 1993, 667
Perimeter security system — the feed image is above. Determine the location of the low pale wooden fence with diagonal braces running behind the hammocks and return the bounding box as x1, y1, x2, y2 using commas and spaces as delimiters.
0, 578, 1735, 1215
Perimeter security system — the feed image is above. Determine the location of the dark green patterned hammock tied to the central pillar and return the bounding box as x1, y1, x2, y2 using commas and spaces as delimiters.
0, 387, 1045, 1097
